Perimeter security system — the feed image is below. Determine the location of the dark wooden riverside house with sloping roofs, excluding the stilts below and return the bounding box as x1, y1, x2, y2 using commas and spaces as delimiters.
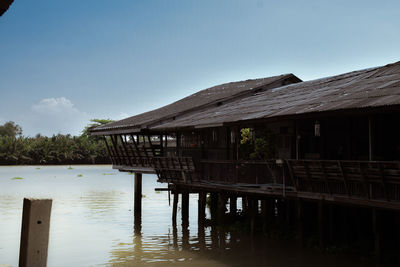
92, 62, 400, 209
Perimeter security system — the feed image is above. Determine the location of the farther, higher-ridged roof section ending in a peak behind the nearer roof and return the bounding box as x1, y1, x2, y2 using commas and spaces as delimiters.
90, 74, 301, 134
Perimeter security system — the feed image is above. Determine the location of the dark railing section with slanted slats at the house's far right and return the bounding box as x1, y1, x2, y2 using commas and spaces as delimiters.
287, 160, 400, 201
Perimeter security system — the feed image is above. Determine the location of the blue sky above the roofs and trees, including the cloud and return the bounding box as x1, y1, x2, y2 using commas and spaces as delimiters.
0, 0, 400, 136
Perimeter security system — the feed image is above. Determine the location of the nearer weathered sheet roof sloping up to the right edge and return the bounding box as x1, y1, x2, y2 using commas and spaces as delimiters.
152, 61, 400, 129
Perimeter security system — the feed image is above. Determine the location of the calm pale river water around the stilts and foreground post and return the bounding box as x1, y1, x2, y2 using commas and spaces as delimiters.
0, 165, 375, 267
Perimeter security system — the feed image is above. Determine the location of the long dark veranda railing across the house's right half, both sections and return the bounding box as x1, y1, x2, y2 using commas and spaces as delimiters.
200, 160, 400, 201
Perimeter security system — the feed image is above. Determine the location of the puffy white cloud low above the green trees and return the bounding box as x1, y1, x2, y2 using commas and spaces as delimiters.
21, 97, 90, 136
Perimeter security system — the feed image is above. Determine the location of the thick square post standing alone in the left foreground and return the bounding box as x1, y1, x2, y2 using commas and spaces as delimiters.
19, 198, 52, 267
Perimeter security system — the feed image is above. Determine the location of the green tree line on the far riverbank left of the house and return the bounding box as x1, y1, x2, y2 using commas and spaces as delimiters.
0, 119, 111, 165
